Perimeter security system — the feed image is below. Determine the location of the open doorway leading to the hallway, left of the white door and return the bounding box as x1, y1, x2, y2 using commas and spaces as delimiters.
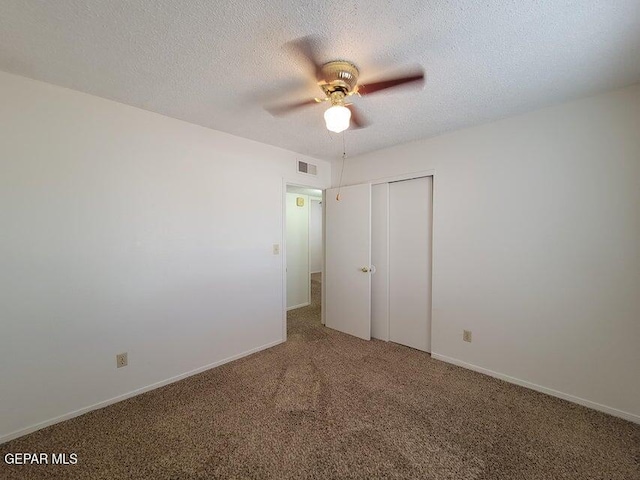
284, 185, 324, 335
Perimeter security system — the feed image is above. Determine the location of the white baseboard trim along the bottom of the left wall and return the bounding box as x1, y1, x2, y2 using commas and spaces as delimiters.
0, 340, 283, 444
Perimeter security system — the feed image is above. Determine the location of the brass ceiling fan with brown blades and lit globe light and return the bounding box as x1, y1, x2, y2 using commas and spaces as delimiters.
266, 37, 424, 133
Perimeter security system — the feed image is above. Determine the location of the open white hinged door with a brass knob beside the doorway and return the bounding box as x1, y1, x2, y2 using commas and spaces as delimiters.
322, 184, 371, 340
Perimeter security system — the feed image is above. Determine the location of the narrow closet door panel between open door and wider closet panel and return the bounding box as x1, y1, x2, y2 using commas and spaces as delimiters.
371, 183, 389, 341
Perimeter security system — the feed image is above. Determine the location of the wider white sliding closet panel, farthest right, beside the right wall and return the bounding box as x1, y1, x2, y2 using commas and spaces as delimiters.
389, 177, 432, 352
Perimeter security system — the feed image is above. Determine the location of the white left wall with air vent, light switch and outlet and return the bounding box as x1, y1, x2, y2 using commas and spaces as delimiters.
0, 69, 330, 441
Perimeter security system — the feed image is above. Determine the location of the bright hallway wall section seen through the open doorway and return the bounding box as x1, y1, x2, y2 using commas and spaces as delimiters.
286, 193, 311, 309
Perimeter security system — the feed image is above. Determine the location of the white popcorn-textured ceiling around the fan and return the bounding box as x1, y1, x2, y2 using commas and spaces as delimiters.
0, 0, 640, 159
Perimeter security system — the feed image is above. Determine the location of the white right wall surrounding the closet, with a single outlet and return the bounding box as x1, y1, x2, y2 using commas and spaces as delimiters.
334, 85, 640, 421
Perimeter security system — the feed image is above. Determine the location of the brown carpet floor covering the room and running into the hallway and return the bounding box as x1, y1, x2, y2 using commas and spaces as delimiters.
0, 281, 640, 480
